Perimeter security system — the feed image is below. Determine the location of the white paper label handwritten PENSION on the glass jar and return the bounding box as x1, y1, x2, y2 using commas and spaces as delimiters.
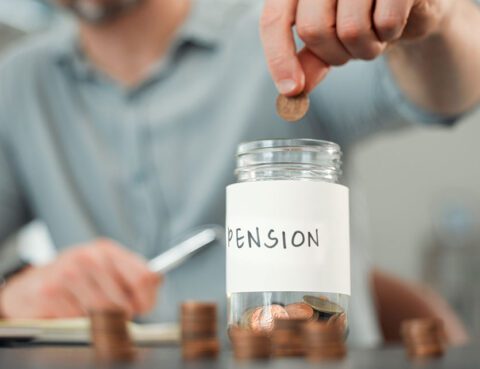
226, 180, 350, 295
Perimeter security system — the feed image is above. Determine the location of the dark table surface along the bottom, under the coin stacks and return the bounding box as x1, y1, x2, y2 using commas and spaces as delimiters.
0, 345, 480, 369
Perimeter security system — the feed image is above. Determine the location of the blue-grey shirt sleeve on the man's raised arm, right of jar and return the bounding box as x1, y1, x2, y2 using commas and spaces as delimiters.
311, 57, 459, 146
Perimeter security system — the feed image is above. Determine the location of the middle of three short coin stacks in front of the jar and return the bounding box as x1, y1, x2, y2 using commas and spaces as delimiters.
272, 318, 307, 357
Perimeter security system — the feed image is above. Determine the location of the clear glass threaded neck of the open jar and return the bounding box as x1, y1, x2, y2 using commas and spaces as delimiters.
235, 139, 342, 183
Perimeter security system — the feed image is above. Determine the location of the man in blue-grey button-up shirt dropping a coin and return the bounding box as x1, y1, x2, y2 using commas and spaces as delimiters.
0, 0, 480, 343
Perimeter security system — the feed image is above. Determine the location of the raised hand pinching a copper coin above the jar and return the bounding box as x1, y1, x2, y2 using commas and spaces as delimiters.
261, 0, 456, 96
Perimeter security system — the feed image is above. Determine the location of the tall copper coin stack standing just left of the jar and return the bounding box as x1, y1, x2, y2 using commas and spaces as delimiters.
180, 302, 220, 360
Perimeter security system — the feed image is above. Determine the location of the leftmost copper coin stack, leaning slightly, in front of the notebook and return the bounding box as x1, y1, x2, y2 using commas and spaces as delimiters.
90, 309, 135, 362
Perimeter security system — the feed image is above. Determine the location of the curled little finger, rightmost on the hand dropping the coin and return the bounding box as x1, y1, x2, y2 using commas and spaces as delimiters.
373, 0, 413, 42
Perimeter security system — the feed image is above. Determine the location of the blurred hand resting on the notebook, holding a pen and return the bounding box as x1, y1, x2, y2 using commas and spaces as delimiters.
0, 240, 161, 318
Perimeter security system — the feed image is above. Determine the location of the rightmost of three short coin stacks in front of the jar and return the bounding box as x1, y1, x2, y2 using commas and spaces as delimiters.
303, 322, 347, 361
